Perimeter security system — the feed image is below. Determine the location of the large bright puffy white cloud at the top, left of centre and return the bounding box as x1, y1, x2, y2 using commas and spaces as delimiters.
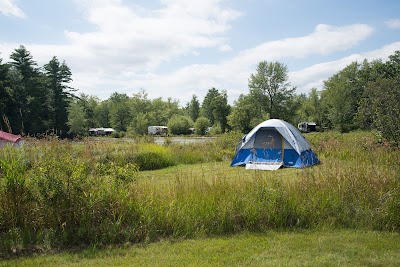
65, 0, 240, 72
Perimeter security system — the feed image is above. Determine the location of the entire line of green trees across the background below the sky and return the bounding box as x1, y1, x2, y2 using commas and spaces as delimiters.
0, 46, 400, 144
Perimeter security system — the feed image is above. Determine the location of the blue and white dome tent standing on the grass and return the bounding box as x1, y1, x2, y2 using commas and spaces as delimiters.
231, 119, 319, 170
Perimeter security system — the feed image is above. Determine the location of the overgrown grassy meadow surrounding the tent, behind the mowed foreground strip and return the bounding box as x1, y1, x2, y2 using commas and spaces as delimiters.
0, 132, 400, 258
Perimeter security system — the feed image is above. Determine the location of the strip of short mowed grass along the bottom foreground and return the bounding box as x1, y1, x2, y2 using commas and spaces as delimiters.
0, 230, 400, 267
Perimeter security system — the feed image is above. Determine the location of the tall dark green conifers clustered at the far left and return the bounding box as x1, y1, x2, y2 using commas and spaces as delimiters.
0, 45, 74, 135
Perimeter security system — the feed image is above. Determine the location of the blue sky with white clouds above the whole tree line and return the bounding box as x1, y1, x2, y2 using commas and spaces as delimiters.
0, 0, 400, 106
